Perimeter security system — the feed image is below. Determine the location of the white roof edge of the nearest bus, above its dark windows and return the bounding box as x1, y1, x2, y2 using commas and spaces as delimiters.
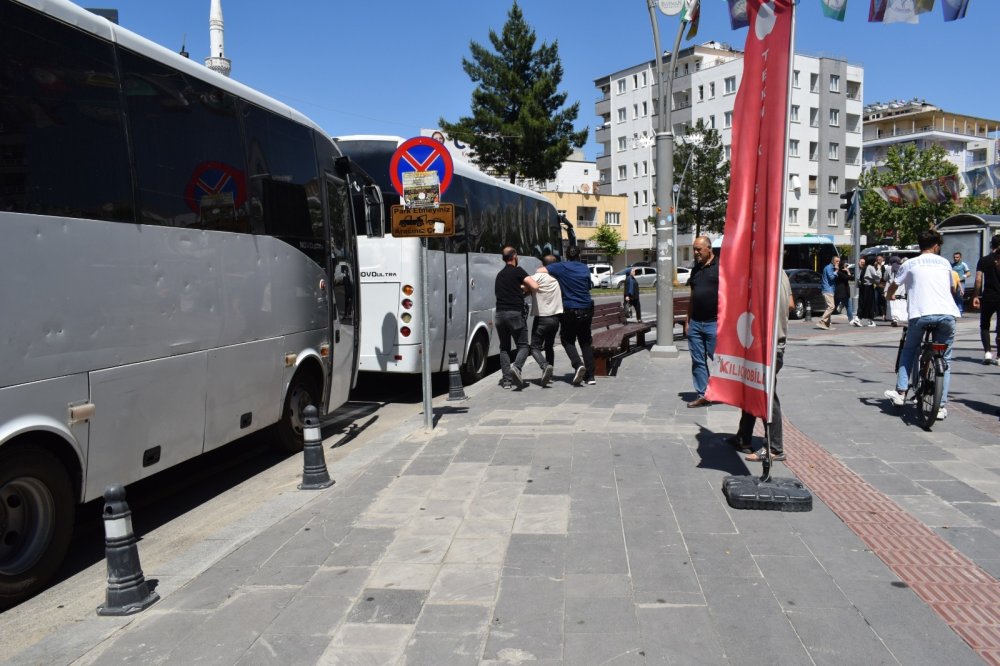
15, 0, 326, 135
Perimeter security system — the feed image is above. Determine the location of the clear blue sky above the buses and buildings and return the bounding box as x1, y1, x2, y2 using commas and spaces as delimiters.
109, 0, 1000, 159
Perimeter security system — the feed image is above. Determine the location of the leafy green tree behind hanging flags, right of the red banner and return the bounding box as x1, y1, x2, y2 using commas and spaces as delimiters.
858, 144, 958, 245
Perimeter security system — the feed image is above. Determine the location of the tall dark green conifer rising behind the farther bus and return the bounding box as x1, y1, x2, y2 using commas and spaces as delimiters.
440, 2, 588, 183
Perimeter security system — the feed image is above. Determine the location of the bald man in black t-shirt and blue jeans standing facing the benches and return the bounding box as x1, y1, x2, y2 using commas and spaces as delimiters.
688, 236, 719, 407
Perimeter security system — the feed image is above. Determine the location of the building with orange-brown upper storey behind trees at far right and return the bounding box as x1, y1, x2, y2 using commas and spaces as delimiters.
862, 98, 1000, 179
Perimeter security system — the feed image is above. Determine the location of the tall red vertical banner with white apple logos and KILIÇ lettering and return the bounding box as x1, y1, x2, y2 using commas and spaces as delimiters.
706, 0, 794, 419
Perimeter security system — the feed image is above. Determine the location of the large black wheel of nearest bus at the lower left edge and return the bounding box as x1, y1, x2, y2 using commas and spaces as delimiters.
0, 445, 76, 610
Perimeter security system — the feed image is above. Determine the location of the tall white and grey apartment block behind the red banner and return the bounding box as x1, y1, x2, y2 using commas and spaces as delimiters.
594, 41, 864, 264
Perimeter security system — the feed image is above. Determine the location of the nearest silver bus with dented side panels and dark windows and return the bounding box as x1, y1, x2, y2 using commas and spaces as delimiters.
0, 0, 370, 606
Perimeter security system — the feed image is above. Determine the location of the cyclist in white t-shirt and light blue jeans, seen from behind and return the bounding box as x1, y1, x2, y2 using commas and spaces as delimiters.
885, 229, 959, 420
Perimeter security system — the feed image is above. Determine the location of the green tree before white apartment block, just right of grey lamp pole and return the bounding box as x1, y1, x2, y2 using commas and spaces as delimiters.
674, 118, 729, 236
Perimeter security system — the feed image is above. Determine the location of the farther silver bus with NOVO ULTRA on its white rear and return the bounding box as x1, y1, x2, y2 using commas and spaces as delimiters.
334, 135, 562, 383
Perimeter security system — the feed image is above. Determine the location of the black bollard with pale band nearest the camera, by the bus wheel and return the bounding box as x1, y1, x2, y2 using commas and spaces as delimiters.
97, 484, 160, 615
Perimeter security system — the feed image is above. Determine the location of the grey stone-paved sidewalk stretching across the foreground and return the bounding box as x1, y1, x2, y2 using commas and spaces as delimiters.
0, 317, 1000, 665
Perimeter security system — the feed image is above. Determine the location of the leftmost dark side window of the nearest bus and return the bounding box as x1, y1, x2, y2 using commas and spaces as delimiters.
0, 2, 135, 222
